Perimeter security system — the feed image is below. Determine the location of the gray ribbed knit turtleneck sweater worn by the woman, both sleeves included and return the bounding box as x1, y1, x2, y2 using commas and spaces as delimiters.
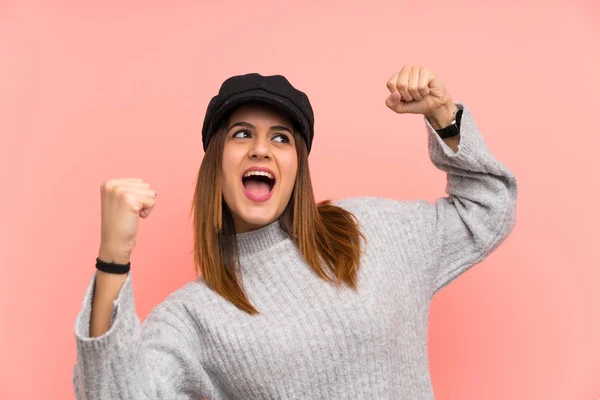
73, 103, 517, 400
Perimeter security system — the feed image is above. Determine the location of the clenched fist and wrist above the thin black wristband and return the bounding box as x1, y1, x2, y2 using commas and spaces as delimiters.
100, 178, 157, 263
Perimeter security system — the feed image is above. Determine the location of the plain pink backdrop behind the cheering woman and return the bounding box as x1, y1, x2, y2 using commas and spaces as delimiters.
0, 0, 600, 400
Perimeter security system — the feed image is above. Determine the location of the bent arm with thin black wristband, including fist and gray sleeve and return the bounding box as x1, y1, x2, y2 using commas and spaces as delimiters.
73, 178, 211, 400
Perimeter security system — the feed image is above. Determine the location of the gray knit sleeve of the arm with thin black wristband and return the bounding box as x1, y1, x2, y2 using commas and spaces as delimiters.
73, 273, 209, 400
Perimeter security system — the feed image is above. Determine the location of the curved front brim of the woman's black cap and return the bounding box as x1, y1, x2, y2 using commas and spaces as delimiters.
209, 89, 310, 144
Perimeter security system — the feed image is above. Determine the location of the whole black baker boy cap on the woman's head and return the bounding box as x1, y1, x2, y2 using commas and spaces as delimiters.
202, 73, 314, 153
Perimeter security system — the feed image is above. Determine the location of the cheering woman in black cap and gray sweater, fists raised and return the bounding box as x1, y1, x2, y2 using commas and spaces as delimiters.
73, 66, 517, 400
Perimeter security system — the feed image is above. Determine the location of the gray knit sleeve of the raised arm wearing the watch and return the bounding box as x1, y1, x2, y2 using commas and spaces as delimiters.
416, 103, 517, 294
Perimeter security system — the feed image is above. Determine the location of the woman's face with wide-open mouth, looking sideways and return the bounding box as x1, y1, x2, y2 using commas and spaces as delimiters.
222, 104, 298, 233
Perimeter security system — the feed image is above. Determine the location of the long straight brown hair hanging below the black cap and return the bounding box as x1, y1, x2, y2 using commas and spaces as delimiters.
191, 114, 366, 314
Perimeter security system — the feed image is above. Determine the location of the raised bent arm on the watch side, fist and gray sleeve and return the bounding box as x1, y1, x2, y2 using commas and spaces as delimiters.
386, 66, 517, 295
